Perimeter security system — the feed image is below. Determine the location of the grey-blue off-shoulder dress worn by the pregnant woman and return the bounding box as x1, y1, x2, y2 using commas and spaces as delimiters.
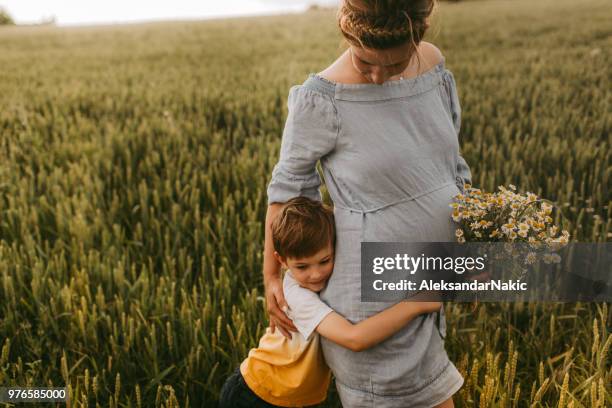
267, 55, 471, 408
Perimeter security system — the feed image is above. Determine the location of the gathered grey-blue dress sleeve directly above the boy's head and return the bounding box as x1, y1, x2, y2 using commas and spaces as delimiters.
267, 85, 339, 205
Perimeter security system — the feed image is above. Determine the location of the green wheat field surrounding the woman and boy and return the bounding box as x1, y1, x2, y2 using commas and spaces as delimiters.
0, 0, 612, 408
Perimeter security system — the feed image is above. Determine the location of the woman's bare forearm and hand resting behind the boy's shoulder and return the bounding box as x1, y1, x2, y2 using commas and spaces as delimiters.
263, 203, 297, 339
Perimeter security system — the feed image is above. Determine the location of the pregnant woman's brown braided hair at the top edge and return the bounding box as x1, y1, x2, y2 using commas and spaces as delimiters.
336, 0, 436, 53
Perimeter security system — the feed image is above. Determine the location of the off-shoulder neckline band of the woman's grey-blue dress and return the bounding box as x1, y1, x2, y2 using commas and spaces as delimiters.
305, 57, 445, 101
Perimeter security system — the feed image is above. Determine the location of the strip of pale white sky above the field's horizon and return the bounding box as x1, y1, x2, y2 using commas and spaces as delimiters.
0, 0, 337, 25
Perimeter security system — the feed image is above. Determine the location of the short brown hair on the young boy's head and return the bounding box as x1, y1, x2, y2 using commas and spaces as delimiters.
272, 197, 336, 258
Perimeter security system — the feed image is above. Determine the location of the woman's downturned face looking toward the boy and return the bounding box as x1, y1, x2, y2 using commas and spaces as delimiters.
349, 43, 412, 85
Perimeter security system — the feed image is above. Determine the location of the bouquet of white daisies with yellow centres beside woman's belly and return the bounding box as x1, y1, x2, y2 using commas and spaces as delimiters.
450, 184, 569, 278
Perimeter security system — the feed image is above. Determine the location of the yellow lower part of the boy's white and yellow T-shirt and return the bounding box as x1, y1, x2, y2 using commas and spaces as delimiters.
240, 327, 331, 407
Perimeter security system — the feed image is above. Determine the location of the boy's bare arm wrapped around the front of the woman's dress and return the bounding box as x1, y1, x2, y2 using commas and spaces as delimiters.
316, 301, 442, 351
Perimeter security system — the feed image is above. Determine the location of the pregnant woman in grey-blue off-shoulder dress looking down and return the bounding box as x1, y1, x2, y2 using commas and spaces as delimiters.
264, 0, 471, 408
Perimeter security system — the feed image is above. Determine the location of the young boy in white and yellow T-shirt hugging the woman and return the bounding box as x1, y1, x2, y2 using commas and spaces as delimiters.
220, 197, 442, 408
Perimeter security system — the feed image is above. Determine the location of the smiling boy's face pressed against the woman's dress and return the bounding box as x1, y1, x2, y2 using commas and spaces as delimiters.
274, 244, 334, 292
